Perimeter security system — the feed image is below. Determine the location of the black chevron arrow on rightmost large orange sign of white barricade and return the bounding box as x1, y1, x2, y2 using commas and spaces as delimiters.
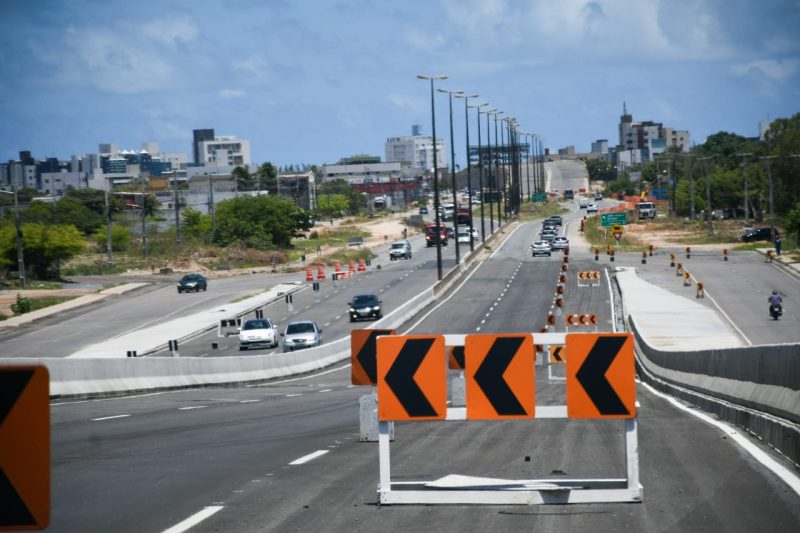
575, 337, 630, 415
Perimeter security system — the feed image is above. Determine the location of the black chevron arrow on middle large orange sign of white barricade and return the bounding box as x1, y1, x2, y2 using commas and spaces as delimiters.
475, 337, 526, 416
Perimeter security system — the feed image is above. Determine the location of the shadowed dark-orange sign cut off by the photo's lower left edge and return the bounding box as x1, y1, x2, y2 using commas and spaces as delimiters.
0, 366, 50, 531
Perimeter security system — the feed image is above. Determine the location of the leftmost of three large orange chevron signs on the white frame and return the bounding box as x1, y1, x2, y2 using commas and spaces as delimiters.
377, 335, 447, 420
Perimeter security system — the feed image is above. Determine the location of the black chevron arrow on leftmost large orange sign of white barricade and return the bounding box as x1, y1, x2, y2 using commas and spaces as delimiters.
386, 339, 437, 417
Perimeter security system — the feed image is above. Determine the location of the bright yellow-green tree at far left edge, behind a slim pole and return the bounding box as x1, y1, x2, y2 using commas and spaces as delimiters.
0, 223, 84, 279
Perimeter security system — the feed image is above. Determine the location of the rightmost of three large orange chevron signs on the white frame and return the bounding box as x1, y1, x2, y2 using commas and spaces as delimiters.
566, 333, 636, 418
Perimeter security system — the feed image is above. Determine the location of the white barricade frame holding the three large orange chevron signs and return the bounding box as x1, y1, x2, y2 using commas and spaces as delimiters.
378, 333, 644, 505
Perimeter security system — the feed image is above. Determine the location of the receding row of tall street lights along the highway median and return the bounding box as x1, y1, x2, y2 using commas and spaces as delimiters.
417, 75, 544, 279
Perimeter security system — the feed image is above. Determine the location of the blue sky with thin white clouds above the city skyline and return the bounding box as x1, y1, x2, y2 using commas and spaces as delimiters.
0, 0, 800, 165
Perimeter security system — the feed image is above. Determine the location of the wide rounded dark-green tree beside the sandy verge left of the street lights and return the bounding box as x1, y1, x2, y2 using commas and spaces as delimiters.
215, 195, 311, 249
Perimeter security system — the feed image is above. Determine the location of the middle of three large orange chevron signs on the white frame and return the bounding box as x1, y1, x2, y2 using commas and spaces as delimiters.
464, 333, 535, 420
